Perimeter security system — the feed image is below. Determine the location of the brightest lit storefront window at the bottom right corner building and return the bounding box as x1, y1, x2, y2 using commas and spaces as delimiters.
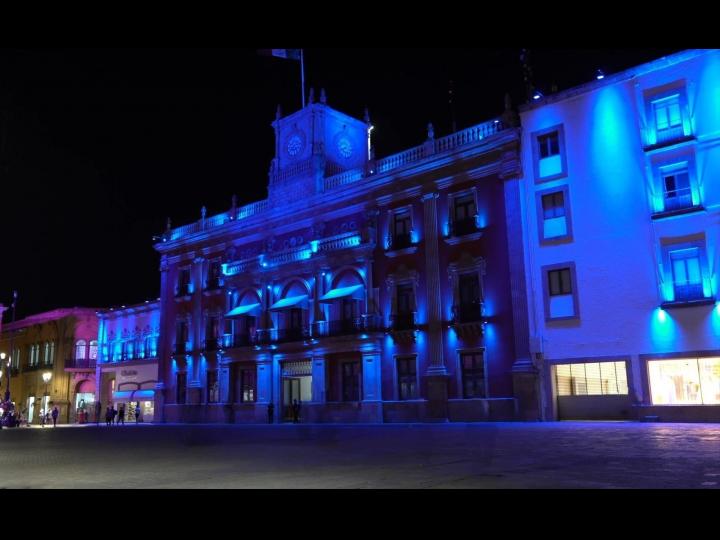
648, 358, 720, 405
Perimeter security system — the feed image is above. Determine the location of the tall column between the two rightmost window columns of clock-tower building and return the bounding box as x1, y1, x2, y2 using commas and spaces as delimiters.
422, 193, 448, 421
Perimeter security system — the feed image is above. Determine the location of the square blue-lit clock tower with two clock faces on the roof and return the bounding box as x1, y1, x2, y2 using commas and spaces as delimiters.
269, 90, 370, 204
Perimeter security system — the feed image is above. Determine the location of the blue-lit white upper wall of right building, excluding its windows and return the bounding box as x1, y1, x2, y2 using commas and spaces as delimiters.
521, 51, 720, 414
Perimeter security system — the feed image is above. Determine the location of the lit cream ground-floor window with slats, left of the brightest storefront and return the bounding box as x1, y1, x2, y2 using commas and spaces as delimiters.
555, 362, 628, 396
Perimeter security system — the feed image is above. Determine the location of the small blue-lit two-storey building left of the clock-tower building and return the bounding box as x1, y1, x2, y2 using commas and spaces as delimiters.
95, 301, 160, 422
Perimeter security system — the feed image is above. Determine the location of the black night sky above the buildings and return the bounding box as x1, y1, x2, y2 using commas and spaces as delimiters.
0, 48, 678, 321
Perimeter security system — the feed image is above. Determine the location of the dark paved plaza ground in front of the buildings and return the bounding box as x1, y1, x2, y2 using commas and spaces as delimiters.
0, 422, 720, 489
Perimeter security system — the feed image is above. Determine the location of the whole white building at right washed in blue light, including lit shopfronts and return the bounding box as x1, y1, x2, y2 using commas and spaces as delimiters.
521, 50, 720, 421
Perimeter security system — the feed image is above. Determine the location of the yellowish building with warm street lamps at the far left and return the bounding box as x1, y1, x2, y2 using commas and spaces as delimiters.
0, 308, 98, 424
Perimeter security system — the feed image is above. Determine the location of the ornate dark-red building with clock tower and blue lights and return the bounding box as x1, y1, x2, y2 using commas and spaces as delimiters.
155, 92, 537, 423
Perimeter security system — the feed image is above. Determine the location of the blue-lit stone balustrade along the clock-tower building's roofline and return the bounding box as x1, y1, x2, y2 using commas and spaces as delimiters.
168, 119, 505, 241
